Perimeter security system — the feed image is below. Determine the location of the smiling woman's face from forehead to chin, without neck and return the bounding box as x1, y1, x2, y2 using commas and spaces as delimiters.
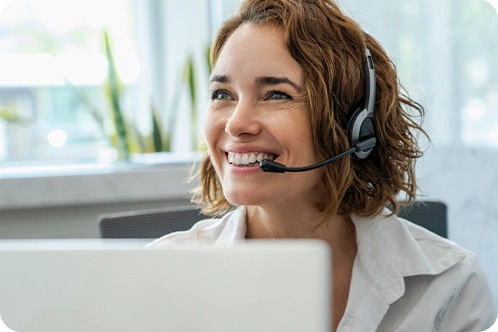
204, 23, 323, 206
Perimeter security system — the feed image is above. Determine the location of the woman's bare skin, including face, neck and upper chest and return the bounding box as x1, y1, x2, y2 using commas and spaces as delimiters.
204, 23, 357, 330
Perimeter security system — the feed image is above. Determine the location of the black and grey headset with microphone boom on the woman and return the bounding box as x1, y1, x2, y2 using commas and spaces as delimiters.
259, 48, 377, 173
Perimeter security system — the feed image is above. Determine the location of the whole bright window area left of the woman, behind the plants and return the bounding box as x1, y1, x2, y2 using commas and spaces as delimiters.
0, 0, 238, 165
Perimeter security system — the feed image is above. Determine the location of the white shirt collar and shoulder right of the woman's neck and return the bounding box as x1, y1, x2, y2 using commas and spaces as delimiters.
353, 212, 497, 331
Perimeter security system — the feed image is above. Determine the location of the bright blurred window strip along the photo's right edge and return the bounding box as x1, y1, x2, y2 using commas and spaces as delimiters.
454, 0, 498, 148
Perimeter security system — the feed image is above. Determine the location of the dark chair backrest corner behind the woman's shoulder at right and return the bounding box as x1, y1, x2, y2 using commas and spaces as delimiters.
398, 201, 448, 238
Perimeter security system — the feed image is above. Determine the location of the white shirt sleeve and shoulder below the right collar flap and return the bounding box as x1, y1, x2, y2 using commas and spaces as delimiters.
379, 245, 498, 331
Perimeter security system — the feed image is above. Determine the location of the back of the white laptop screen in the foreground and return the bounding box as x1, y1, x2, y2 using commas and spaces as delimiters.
0, 240, 330, 332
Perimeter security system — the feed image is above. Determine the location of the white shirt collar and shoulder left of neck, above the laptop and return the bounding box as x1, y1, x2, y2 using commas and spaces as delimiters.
146, 207, 245, 248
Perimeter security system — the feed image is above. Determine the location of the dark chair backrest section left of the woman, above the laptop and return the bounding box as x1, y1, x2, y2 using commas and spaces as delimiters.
97, 205, 208, 239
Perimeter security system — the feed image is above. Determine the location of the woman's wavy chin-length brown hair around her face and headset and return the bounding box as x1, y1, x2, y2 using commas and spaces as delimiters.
193, 0, 427, 220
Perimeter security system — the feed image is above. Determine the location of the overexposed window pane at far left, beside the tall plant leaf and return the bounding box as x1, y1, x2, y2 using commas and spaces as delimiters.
0, 0, 139, 162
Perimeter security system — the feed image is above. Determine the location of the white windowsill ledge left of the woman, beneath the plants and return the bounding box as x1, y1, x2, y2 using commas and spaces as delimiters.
0, 154, 197, 208
